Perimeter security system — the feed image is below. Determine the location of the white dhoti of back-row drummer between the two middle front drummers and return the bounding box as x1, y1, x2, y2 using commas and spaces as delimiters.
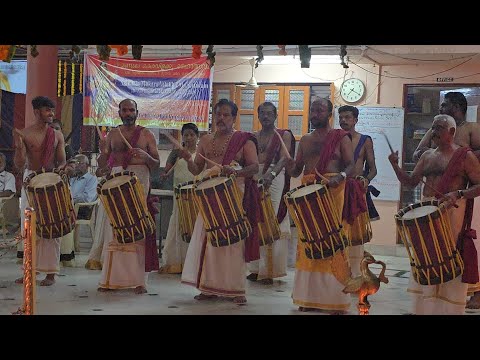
248, 166, 291, 280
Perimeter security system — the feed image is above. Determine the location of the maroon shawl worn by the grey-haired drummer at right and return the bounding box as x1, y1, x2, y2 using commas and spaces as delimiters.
435, 147, 479, 284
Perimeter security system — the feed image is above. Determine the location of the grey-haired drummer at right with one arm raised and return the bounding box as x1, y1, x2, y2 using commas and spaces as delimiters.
388, 115, 480, 315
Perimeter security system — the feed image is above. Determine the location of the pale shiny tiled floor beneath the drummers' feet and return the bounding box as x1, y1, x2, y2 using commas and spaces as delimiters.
0, 232, 476, 316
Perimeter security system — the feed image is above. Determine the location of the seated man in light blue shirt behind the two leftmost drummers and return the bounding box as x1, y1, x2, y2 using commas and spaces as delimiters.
60, 154, 97, 266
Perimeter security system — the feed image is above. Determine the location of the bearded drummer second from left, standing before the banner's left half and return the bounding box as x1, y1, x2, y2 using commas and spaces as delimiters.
98, 99, 160, 294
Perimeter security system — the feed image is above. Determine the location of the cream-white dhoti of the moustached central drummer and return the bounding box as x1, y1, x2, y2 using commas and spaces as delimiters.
181, 179, 246, 297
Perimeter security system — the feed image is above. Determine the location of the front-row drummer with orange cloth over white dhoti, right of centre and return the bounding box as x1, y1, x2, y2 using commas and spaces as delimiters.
286, 99, 355, 312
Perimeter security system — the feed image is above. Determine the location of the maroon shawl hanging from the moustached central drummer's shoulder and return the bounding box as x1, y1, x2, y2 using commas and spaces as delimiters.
222, 131, 260, 262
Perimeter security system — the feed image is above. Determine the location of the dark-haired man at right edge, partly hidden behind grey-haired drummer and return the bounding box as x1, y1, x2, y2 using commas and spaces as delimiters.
413, 91, 480, 309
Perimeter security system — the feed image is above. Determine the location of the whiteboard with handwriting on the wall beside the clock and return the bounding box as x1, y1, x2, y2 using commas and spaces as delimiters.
334, 106, 404, 201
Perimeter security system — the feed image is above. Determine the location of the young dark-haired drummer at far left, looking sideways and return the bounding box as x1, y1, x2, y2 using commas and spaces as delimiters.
13, 96, 65, 286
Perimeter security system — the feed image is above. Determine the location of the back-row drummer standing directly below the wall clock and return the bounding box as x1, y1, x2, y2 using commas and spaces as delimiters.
338, 105, 377, 277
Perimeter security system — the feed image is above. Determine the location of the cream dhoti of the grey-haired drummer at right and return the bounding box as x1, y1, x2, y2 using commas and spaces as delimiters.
407, 199, 468, 315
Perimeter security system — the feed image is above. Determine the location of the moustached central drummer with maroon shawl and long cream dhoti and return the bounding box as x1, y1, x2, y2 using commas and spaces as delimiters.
180, 99, 260, 304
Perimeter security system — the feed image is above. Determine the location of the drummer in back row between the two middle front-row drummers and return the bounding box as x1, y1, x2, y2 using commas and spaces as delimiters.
247, 102, 295, 285
